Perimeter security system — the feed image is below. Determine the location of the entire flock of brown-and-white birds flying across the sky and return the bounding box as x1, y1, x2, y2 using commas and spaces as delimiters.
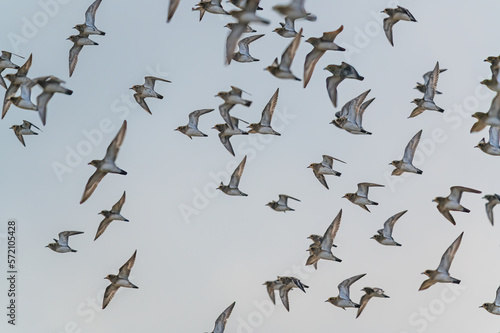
0, 0, 500, 333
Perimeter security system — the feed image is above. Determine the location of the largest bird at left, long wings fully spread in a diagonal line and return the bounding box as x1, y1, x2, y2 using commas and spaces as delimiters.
80, 120, 127, 204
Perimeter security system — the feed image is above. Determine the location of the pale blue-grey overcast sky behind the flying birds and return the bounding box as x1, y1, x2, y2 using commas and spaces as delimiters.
0, 0, 500, 333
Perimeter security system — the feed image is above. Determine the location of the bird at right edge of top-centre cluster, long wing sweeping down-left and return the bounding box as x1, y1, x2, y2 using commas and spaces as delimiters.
304, 25, 345, 88
